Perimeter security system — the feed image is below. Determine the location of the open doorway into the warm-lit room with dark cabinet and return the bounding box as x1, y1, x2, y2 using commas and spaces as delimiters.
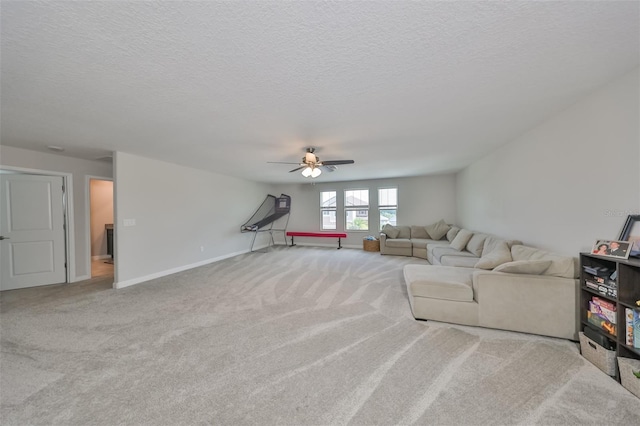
89, 177, 115, 278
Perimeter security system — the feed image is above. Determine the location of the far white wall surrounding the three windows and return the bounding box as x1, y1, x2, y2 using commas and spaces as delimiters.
274, 171, 456, 247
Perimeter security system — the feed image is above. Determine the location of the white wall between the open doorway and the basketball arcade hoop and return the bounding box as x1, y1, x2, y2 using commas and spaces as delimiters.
114, 152, 270, 287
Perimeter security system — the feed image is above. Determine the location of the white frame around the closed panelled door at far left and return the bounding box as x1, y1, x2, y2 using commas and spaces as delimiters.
0, 165, 76, 283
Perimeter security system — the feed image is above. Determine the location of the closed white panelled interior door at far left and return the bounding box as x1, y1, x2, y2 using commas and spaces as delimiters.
0, 174, 67, 290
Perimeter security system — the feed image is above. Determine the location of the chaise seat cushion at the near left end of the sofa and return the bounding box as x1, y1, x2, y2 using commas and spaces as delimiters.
404, 265, 473, 302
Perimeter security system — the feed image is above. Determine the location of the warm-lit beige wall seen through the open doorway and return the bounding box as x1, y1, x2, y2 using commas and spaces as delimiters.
89, 179, 113, 257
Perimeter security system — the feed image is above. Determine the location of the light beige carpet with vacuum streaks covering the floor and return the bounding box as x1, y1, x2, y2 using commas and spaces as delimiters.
0, 246, 640, 425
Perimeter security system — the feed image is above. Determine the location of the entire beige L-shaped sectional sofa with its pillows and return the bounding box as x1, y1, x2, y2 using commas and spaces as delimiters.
380, 221, 579, 340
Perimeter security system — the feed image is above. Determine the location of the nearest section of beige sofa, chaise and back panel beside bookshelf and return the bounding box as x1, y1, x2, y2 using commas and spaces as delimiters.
404, 245, 579, 340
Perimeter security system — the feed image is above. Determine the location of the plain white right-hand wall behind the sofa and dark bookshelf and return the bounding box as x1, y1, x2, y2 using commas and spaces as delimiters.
456, 69, 640, 256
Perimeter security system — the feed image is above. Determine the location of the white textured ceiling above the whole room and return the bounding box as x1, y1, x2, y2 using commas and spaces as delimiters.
0, 0, 640, 182
